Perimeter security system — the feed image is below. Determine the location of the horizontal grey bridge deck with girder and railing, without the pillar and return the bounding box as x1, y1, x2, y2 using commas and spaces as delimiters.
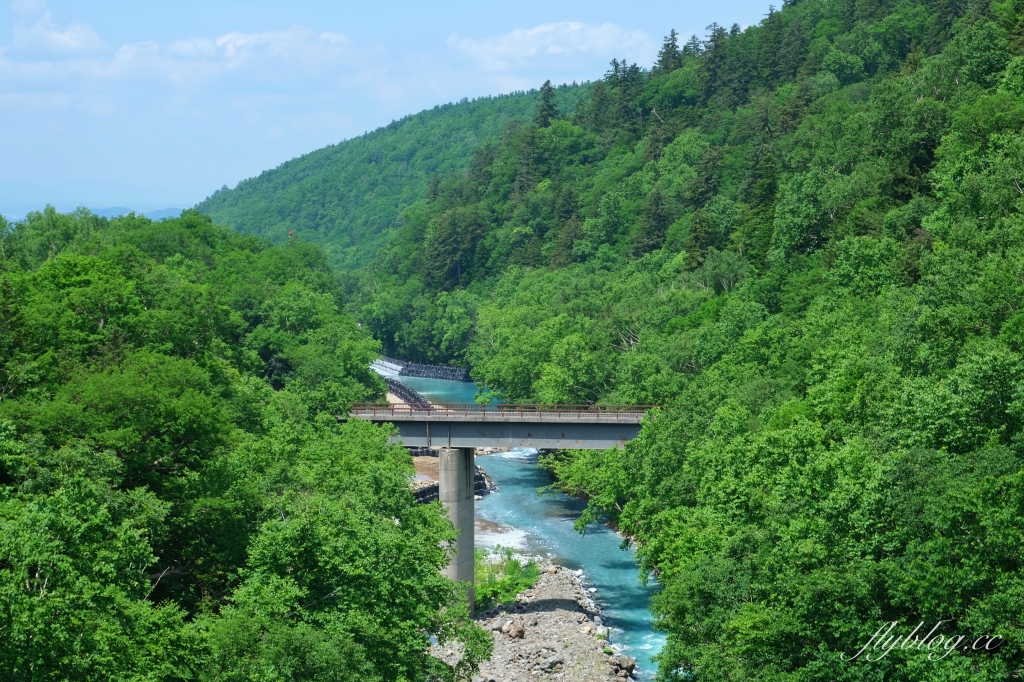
349, 403, 649, 450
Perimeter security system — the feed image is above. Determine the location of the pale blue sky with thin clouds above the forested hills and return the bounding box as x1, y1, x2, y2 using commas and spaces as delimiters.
0, 0, 768, 216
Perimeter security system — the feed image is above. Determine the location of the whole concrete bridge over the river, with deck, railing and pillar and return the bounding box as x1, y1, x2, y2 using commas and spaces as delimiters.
349, 403, 650, 610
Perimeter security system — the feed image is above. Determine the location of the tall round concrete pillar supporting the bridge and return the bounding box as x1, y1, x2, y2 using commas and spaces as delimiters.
438, 447, 476, 613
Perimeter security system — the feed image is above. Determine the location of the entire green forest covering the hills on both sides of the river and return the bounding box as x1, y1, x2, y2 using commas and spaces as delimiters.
8, 0, 1024, 671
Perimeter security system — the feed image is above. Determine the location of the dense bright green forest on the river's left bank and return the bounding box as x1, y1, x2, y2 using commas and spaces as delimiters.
0, 209, 490, 682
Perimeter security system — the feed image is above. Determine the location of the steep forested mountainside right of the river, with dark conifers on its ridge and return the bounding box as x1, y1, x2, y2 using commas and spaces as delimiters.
344, 0, 1024, 682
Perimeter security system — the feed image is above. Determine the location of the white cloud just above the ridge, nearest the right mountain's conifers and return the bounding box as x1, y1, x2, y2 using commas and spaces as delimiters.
447, 22, 657, 71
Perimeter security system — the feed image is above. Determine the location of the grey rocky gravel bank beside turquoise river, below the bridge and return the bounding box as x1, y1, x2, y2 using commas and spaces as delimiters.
435, 565, 635, 682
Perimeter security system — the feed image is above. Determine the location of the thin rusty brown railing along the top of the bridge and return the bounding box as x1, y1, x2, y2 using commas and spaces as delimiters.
350, 402, 657, 421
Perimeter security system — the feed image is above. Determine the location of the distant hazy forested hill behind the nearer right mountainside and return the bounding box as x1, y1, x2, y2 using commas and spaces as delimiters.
197, 86, 587, 268
